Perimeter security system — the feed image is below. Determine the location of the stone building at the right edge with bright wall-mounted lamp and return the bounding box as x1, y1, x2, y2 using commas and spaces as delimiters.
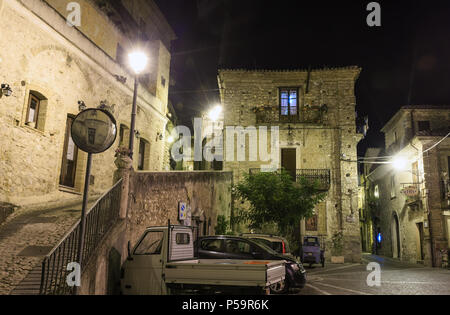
367, 106, 450, 266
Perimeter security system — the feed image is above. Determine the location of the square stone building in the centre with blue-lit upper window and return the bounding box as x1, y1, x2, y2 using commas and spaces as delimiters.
218, 67, 363, 262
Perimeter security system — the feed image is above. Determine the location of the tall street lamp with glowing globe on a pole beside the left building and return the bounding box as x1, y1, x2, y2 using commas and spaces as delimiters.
128, 51, 148, 159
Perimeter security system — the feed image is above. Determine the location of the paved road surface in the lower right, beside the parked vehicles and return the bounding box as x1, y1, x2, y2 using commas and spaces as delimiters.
294, 255, 450, 295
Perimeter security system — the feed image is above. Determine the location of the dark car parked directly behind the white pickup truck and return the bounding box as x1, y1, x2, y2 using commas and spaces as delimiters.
194, 236, 306, 294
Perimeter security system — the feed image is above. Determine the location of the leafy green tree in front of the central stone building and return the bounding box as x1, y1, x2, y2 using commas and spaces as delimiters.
235, 171, 325, 241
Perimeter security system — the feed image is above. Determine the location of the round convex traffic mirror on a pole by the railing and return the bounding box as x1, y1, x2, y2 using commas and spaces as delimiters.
72, 108, 117, 153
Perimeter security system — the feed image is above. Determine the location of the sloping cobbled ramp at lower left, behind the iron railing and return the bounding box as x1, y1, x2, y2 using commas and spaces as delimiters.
0, 204, 95, 295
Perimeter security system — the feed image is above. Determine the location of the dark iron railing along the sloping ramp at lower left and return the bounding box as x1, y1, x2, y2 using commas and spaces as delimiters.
40, 180, 122, 295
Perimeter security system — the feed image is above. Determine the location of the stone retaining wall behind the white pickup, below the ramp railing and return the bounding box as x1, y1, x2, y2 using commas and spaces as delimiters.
80, 172, 232, 295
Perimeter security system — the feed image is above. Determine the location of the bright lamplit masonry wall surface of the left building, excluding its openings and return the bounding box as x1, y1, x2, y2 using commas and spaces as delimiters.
0, 0, 170, 210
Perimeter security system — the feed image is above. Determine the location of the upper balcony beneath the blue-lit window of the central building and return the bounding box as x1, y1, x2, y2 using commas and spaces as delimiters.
254, 105, 327, 124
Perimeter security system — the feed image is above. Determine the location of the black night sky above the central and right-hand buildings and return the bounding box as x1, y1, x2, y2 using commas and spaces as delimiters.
155, 0, 450, 154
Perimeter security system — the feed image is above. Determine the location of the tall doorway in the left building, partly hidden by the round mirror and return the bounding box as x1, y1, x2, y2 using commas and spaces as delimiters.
59, 115, 78, 188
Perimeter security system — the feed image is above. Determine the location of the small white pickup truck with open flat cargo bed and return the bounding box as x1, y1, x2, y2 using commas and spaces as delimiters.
121, 224, 285, 295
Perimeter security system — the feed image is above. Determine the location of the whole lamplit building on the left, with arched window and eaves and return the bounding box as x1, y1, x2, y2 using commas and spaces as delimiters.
0, 0, 175, 207
